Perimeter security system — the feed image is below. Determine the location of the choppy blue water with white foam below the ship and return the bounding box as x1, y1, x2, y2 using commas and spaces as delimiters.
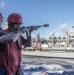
21, 57, 74, 75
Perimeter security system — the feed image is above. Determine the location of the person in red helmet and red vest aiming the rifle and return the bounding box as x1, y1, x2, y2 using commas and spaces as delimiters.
0, 13, 31, 75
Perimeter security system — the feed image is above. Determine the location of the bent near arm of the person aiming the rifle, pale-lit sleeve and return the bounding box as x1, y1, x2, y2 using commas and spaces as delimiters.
0, 31, 22, 43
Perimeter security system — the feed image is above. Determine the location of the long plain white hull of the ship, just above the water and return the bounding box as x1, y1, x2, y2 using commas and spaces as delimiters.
22, 51, 74, 59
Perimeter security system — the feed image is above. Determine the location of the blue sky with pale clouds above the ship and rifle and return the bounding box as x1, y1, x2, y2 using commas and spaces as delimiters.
0, 0, 74, 38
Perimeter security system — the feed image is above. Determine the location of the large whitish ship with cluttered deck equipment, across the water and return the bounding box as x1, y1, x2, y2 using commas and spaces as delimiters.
22, 29, 74, 59
